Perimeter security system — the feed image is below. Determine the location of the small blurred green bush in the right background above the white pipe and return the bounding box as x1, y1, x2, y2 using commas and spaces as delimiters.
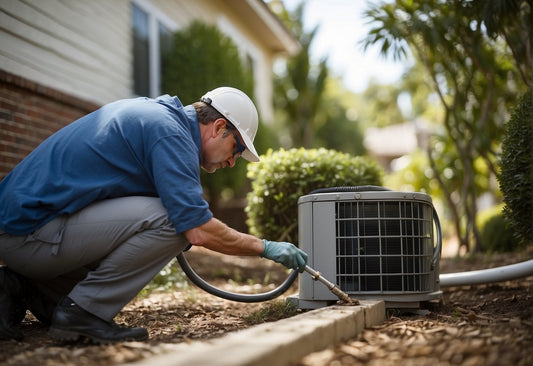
477, 205, 517, 253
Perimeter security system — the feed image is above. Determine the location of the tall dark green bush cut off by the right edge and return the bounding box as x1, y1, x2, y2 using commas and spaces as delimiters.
498, 91, 533, 247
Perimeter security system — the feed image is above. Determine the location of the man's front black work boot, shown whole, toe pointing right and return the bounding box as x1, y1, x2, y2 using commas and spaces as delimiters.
48, 297, 148, 343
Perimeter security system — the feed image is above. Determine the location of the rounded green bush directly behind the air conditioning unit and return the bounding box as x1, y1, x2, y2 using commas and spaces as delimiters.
246, 148, 383, 244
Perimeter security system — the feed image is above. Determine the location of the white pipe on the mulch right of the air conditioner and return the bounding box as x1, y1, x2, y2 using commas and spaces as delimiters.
439, 259, 533, 287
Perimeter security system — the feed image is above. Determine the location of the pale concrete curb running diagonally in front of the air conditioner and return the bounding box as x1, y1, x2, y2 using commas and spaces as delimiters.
130, 300, 385, 366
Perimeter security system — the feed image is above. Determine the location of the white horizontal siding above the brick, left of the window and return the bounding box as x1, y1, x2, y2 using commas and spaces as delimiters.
0, 0, 132, 104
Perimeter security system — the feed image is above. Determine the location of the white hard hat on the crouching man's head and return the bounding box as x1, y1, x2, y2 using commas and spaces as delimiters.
200, 86, 259, 161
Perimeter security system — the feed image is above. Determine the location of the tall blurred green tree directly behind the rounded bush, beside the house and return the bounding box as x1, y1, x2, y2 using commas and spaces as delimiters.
269, 0, 365, 154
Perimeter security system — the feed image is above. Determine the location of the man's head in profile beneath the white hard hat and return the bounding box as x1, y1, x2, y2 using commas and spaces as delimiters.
201, 118, 244, 173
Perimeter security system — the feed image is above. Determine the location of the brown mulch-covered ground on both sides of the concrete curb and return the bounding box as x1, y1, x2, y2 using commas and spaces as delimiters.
0, 248, 533, 366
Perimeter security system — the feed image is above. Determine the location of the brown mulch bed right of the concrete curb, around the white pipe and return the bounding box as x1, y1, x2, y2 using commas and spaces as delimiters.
292, 248, 533, 366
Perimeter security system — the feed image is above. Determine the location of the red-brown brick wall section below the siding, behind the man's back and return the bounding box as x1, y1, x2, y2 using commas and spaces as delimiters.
0, 70, 98, 180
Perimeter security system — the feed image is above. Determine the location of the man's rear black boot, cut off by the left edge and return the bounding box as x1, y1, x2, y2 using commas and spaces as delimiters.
0, 266, 26, 341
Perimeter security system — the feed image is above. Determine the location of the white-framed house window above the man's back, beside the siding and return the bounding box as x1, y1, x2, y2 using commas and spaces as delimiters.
131, 0, 177, 97
